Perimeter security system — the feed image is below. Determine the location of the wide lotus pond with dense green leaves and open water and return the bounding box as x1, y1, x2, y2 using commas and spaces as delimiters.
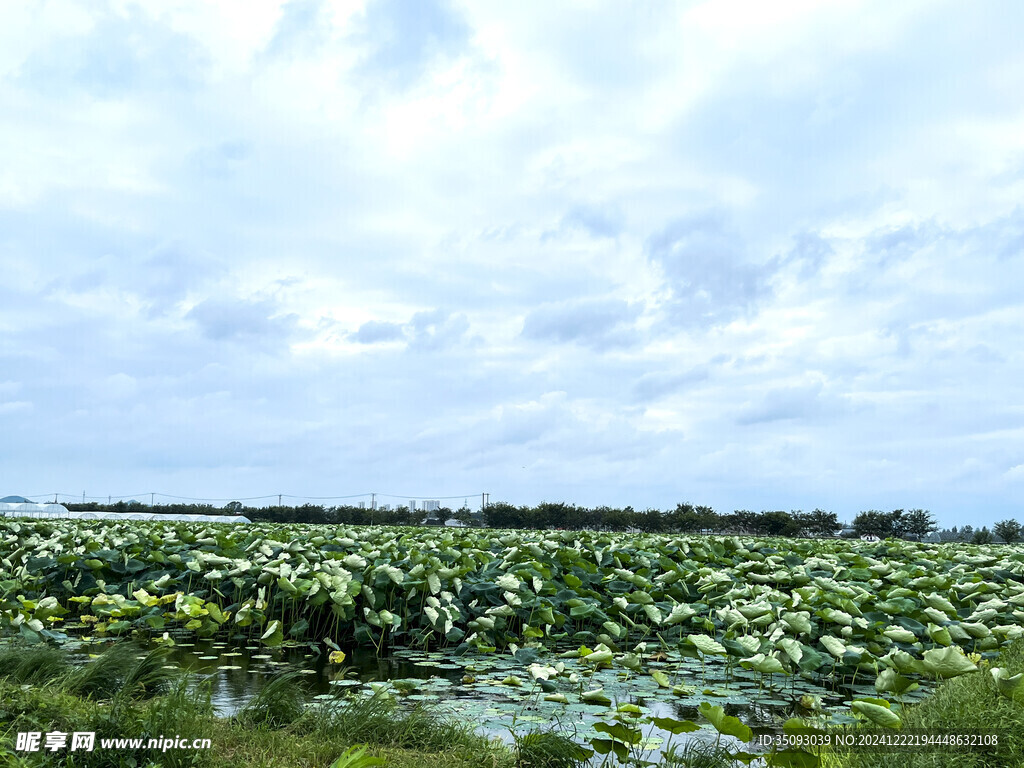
0, 520, 1024, 737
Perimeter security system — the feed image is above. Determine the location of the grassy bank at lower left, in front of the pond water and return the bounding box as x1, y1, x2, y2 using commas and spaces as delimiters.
0, 646, 516, 768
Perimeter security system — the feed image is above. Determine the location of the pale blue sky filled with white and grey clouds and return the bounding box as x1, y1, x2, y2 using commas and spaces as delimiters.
0, 0, 1024, 527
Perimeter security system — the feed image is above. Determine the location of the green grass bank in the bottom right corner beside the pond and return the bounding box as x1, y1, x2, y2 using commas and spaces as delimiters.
821, 641, 1024, 768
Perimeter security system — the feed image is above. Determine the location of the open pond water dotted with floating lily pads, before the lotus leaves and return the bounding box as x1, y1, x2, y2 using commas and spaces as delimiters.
68, 638, 927, 761
